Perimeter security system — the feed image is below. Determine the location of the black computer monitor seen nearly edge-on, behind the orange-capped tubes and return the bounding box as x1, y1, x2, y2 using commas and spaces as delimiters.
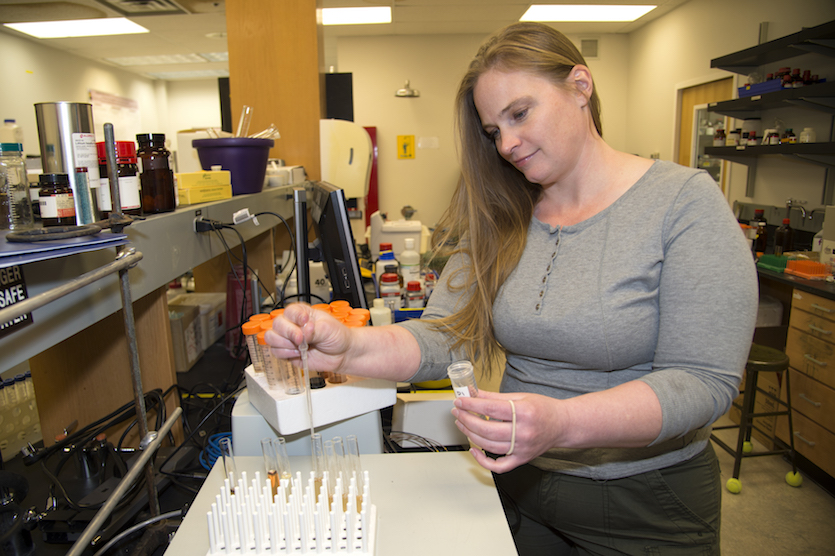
307, 181, 368, 309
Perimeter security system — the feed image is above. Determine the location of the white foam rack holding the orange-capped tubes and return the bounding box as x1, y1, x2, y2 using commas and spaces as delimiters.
245, 365, 397, 436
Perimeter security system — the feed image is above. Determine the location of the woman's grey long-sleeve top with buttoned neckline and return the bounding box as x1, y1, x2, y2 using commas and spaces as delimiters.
402, 161, 757, 479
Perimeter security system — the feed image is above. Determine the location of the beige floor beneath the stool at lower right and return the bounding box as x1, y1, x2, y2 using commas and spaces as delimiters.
714, 421, 835, 556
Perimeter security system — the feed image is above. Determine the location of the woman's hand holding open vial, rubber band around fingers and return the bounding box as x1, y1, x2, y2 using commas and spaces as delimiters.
452, 390, 568, 473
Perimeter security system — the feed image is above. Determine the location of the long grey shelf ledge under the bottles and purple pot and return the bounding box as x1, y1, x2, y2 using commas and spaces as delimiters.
0, 184, 304, 372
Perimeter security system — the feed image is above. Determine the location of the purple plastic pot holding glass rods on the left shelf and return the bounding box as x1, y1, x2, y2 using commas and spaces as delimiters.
191, 137, 275, 195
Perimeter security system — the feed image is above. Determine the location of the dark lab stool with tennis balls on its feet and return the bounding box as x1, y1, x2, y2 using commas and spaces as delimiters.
710, 344, 803, 494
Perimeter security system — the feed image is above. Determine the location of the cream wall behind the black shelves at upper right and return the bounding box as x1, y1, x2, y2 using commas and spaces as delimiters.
627, 0, 835, 212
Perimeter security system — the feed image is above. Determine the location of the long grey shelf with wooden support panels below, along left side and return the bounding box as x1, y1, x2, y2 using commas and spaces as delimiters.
0, 186, 293, 452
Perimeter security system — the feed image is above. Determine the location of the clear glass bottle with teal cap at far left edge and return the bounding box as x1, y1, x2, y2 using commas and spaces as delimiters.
0, 143, 35, 231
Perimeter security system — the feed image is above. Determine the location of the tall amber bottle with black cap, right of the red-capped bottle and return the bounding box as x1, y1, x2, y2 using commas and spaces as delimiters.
136, 133, 177, 214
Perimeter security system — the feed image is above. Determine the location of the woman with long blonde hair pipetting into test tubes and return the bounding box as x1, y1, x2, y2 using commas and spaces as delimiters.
267, 23, 757, 555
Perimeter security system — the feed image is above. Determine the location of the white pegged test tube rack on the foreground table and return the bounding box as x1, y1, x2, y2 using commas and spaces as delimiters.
206, 471, 377, 556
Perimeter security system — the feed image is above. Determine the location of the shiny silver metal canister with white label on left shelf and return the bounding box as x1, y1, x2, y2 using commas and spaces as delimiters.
35, 102, 99, 225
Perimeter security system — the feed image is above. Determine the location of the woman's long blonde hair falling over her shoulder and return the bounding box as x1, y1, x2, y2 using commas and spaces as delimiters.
432, 23, 602, 372
